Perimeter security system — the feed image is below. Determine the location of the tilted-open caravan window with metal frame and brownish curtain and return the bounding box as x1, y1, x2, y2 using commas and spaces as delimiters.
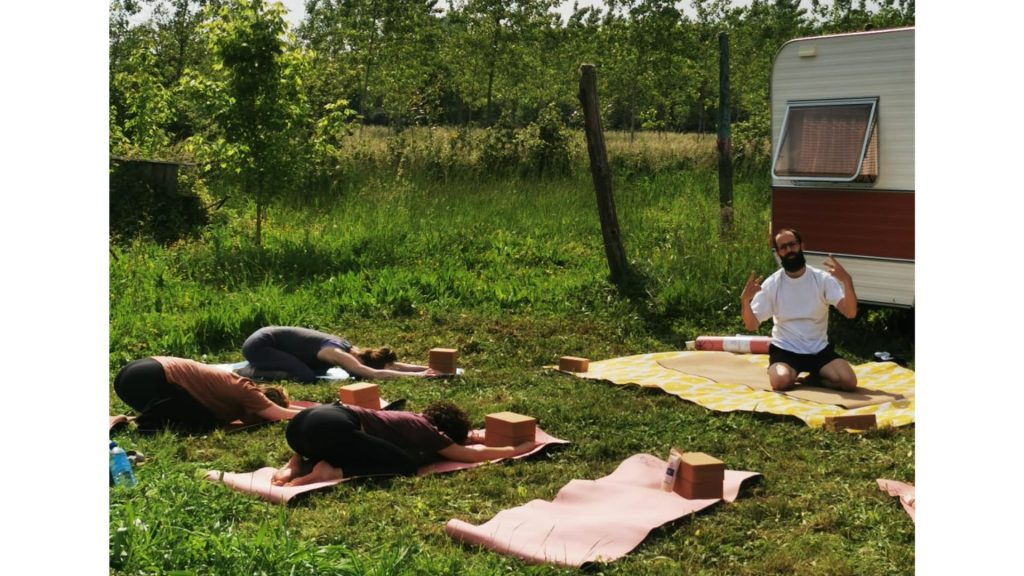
772, 98, 879, 182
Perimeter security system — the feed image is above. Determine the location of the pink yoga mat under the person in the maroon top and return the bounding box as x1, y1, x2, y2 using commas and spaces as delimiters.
205, 427, 568, 504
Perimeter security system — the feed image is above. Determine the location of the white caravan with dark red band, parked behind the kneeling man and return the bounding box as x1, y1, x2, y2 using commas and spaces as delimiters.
771, 28, 914, 307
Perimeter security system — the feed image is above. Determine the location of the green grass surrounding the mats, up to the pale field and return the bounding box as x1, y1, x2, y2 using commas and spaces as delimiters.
110, 136, 914, 576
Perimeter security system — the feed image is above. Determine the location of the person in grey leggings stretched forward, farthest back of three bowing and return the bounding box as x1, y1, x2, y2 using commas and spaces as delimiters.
242, 326, 437, 382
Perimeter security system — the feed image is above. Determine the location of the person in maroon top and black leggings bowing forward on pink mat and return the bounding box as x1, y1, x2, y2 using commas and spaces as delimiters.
271, 401, 536, 486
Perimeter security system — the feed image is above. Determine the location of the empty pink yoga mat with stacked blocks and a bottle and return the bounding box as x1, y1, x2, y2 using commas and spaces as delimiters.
444, 454, 760, 567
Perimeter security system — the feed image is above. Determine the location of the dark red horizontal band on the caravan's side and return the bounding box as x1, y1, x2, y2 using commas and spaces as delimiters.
771, 188, 913, 260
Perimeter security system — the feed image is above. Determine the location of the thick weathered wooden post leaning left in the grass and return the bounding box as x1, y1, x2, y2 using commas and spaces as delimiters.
580, 64, 628, 288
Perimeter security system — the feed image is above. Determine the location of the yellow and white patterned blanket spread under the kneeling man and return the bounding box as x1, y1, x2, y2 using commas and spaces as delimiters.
572, 352, 914, 427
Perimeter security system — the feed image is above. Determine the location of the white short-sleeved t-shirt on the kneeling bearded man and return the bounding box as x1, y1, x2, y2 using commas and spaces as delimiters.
751, 265, 845, 354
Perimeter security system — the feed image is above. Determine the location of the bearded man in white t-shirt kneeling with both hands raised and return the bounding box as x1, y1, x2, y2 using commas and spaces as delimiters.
739, 229, 857, 392
